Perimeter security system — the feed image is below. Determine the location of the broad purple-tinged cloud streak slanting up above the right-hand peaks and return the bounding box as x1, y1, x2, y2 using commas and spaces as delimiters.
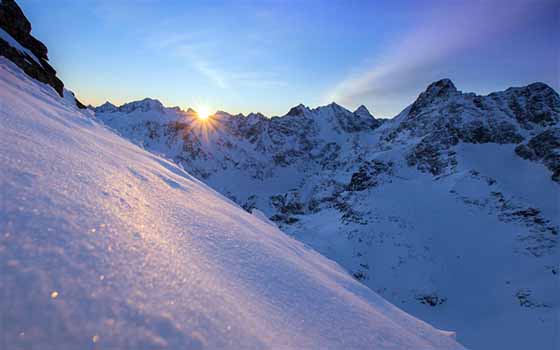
327, 0, 552, 117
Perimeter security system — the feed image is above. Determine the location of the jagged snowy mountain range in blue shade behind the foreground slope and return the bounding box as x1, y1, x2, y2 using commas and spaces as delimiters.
95, 79, 560, 349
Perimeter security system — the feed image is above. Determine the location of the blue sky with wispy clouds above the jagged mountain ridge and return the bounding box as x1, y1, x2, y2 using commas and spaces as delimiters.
18, 0, 560, 117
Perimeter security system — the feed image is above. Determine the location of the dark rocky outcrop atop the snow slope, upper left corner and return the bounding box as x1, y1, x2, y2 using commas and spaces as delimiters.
0, 0, 80, 104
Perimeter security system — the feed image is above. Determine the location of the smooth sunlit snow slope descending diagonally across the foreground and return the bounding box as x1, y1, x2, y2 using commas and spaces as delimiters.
0, 58, 462, 349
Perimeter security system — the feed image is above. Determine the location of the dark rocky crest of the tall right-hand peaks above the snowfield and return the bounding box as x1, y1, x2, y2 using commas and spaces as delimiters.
383, 79, 560, 178
